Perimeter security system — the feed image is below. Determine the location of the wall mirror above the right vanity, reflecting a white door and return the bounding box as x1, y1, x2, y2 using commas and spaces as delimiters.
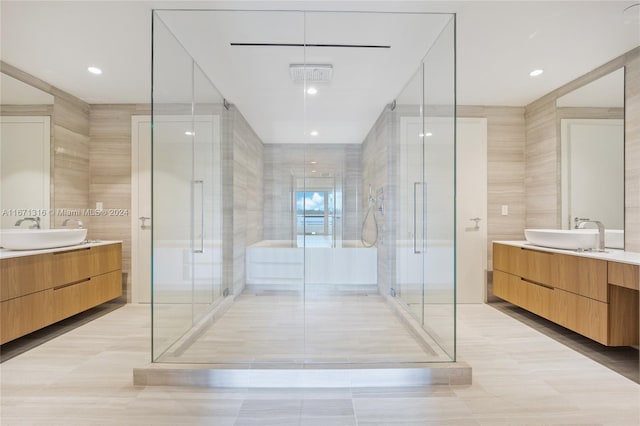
556, 68, 624, 248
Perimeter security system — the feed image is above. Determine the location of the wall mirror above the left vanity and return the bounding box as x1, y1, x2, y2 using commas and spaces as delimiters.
0, 73, 54, 229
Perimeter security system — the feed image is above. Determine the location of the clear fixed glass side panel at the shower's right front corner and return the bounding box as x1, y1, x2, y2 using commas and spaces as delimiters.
423, 18, 456, 360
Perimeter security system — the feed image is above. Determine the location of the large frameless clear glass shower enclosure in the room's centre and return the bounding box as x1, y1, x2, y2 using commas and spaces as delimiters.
152, 10, 456, 367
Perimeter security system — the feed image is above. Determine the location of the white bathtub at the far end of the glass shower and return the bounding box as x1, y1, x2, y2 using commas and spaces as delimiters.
246, 240, 378, 286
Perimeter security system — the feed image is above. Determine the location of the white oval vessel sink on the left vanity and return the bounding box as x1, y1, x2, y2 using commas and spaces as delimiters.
0, 229, 87, 250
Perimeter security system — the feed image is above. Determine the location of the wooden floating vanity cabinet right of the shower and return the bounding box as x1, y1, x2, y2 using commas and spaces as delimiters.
493, 243, 639, 346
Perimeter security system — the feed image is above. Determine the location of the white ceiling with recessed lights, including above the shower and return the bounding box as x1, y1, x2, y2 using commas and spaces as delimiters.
0, 0, 640, 142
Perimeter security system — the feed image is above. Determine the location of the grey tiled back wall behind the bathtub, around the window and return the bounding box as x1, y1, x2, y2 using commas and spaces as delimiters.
264, 144, 360, 240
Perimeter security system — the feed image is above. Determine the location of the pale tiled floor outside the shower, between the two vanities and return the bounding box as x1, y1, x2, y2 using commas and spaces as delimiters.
0, 305, 640, 426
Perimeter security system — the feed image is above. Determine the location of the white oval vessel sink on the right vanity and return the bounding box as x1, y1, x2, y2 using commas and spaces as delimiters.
524, 229, 598, 250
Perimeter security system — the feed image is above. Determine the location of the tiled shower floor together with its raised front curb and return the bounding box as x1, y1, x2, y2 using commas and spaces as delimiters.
134, 289, 471, 387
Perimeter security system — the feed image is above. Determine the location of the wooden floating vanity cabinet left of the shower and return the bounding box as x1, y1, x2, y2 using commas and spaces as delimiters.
0, 243, 122, 343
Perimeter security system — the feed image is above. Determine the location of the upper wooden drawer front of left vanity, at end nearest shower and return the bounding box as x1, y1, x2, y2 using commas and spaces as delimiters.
52, 244, 122, 286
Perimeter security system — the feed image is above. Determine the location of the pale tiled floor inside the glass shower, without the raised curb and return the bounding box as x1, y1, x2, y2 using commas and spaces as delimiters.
162, 291, 453, 365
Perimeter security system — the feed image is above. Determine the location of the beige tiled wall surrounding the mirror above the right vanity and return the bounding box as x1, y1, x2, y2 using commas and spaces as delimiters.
525, 47, 640, 251
